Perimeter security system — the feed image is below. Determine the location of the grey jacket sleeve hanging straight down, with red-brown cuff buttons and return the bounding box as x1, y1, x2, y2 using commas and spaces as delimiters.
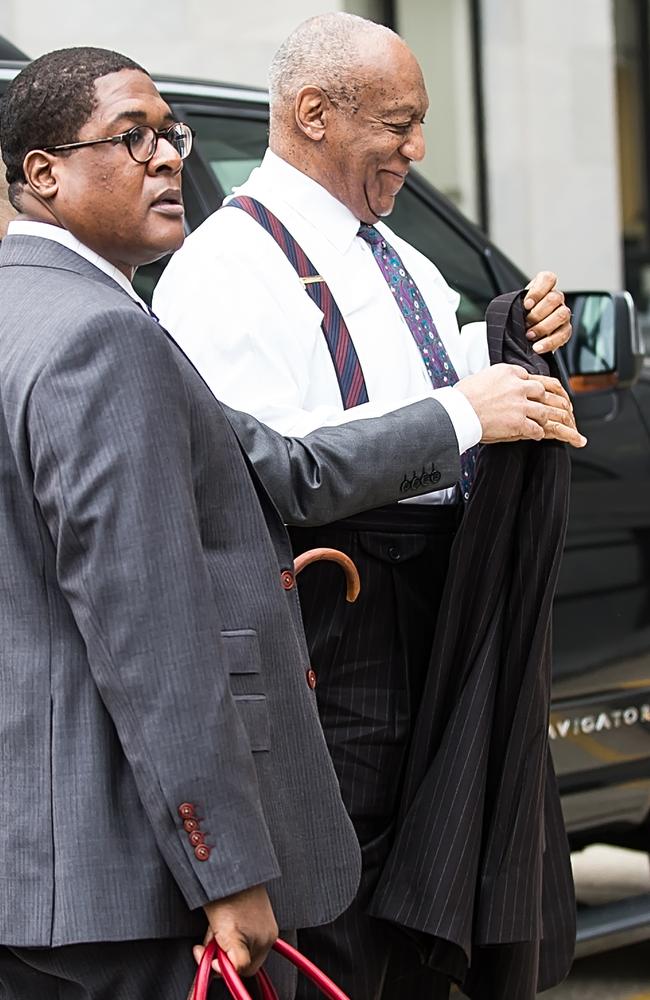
27, 308, 279, 908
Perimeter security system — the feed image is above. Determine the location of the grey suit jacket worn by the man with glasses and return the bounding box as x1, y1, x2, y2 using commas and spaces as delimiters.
0, 236, 458, 946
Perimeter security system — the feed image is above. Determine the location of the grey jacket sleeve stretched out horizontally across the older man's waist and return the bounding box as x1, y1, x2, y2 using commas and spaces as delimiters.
224, 399, 460, 525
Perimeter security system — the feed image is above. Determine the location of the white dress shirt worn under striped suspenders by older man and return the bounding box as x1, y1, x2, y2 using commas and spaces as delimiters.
153, 150, 488, 502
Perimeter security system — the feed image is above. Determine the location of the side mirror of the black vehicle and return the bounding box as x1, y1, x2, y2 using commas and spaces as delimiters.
563, 292, 644, 393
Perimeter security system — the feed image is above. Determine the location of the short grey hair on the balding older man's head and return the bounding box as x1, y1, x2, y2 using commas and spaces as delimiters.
269, 11, 399, 114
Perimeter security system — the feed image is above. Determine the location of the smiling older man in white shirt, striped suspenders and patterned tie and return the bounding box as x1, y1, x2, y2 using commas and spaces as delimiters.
154, 14, 570, 1000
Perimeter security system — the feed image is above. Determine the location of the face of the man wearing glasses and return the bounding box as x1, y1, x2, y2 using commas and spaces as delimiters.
25, 69, 184, 278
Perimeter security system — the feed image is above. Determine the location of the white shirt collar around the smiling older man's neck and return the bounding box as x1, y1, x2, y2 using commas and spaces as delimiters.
235, 149, 359, 253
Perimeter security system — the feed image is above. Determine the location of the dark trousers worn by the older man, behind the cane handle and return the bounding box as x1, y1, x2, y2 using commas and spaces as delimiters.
291, 504, 460, 1000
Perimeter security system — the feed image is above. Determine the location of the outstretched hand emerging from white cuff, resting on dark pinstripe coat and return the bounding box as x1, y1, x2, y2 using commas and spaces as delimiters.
456, 364, 587, 448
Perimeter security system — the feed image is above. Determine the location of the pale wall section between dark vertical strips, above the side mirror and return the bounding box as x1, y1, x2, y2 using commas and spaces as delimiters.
482, 0, 622, 289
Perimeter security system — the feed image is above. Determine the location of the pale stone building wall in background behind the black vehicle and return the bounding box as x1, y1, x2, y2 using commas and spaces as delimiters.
0, 0, 622, 288
